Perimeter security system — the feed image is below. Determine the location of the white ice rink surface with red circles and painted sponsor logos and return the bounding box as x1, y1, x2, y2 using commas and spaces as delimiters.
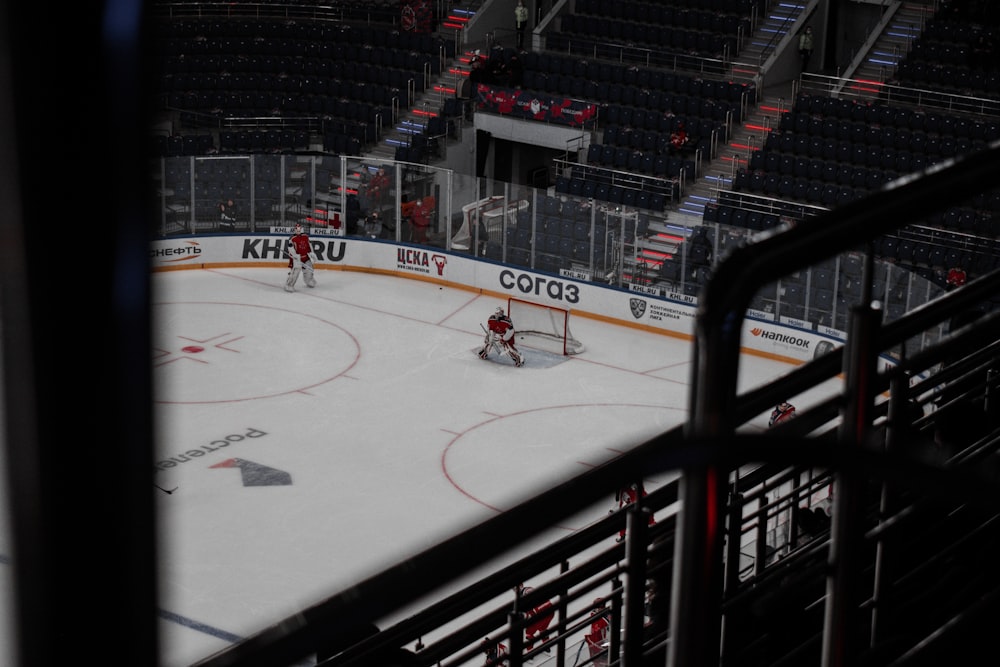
0, 268, 824, 667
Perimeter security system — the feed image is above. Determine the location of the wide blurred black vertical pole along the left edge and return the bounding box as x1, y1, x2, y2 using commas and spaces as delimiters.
0, 0, 160, 667
